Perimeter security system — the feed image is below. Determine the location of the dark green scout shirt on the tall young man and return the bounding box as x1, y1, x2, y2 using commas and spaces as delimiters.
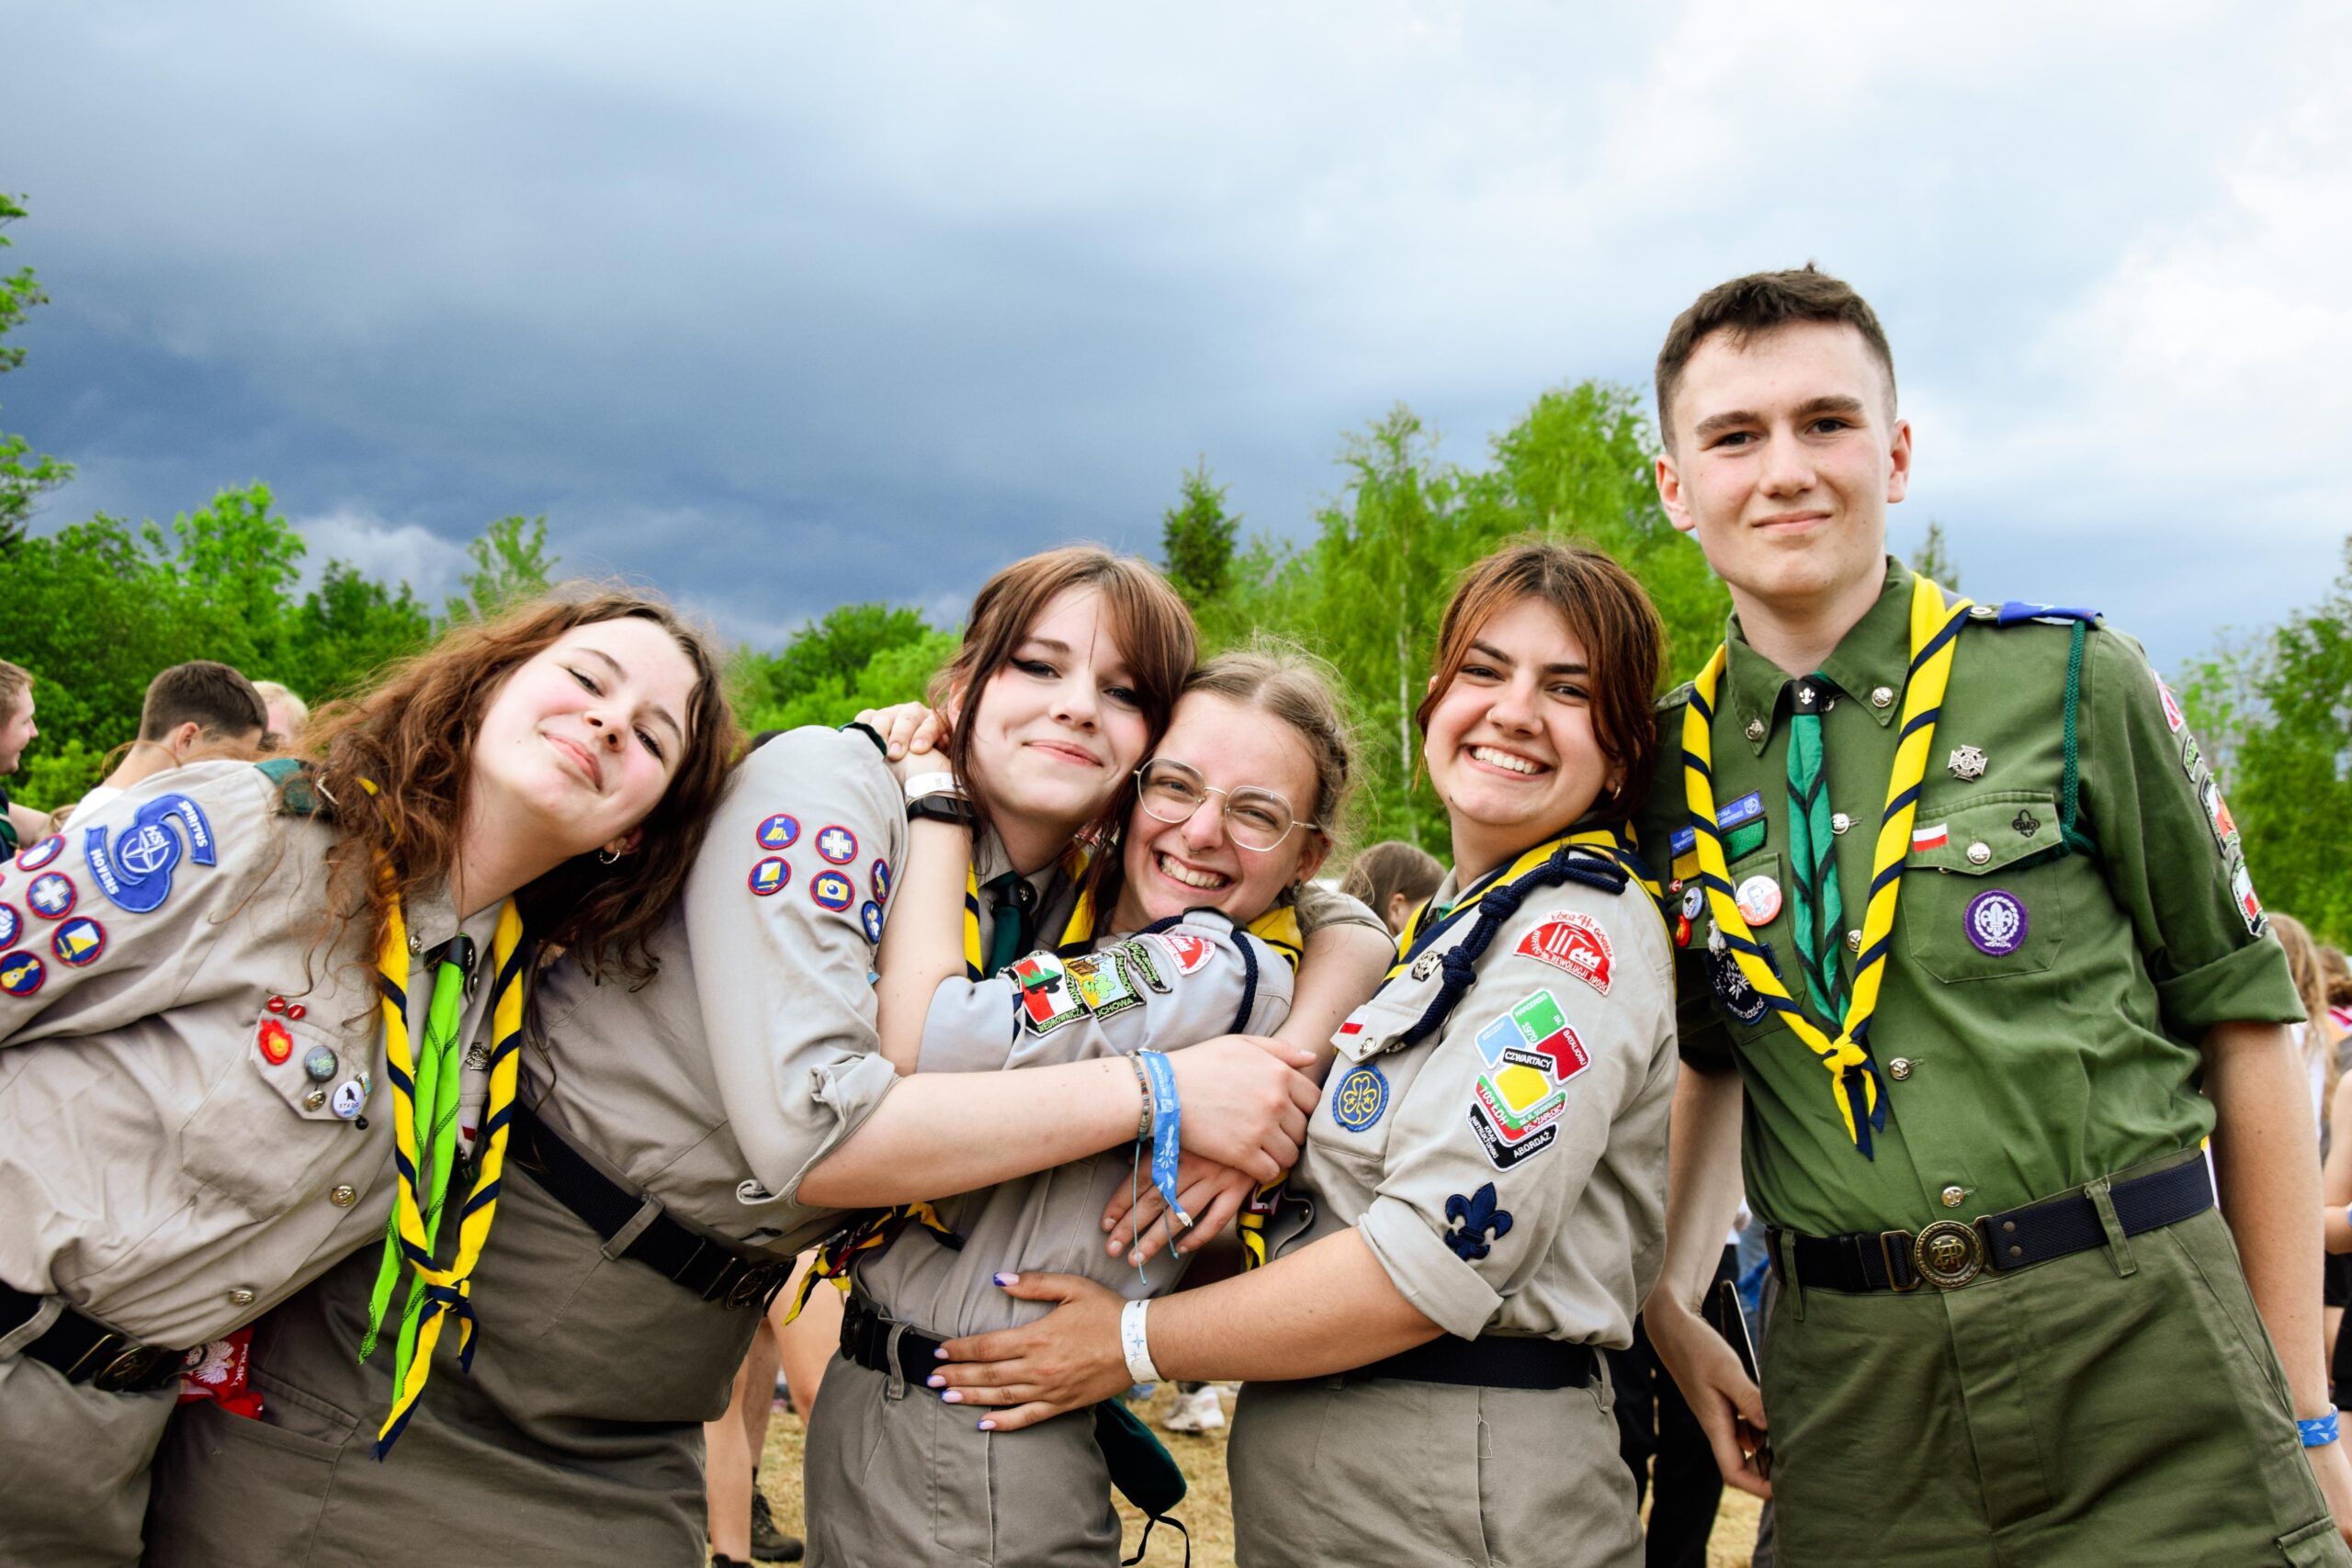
1642, 559, 2302, 1235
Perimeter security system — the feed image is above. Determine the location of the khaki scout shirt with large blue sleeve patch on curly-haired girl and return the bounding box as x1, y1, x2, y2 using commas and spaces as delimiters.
0, 761, 499, 1347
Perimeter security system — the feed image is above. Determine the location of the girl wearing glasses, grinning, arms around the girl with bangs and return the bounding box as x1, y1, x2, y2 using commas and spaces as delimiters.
807, 653, 1393, 1565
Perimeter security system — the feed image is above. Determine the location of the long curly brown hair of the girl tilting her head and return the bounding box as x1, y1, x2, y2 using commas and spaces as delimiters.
303, 585, 739, 980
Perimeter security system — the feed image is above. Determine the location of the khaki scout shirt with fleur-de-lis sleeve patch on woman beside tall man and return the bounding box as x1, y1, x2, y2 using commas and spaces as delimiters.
1268, 874, 1675, 1347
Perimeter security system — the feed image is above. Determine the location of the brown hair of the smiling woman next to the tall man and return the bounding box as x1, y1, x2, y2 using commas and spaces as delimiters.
1414, 538, 1665, 825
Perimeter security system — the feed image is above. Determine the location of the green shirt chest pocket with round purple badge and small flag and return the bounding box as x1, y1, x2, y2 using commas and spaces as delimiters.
1895, 790, 2065, 983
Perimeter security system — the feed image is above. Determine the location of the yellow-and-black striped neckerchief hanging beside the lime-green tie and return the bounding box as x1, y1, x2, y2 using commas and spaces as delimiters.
377, 898, 522, 1460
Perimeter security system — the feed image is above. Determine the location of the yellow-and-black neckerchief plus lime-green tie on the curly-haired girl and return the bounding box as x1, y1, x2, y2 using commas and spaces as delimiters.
360, 898, 525, 1460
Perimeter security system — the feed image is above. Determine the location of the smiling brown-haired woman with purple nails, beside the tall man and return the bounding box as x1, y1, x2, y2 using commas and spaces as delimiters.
944, 543, 1675, 1568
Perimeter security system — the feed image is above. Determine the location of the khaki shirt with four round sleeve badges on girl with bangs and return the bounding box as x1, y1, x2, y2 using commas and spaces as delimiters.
522, 727, 906, 1256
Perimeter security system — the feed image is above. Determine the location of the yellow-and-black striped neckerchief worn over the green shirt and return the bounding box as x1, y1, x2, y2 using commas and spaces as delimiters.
1681, 576, 1969, 1159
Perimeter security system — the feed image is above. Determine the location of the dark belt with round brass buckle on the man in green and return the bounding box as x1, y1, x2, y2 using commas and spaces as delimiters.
1771, 1159, 2213, 1295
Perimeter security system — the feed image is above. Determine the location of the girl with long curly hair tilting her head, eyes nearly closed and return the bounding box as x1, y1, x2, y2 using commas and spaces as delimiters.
0, 592, 729, 1568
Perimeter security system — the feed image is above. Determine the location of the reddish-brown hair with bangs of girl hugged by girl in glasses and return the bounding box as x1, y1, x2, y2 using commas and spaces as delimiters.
929, 546, 1194, 908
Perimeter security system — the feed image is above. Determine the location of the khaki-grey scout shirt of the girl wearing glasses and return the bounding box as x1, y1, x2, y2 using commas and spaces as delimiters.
858, 909, 1294, 1337
